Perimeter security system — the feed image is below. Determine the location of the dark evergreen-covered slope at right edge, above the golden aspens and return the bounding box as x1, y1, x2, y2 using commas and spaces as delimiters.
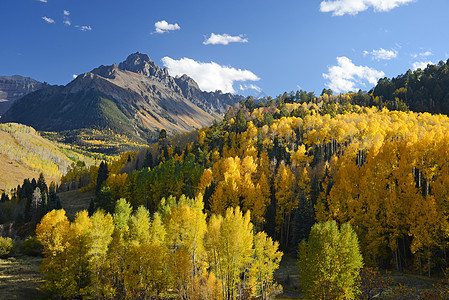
373, 60, 449, 115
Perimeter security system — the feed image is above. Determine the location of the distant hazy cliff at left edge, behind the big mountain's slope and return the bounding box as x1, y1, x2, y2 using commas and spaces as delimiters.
0, 75, 48, 116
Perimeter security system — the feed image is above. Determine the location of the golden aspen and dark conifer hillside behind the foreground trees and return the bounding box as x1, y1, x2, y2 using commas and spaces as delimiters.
72, 94, 449, 274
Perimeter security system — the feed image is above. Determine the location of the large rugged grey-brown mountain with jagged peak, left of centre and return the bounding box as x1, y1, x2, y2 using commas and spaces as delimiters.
0, 52, 244, 141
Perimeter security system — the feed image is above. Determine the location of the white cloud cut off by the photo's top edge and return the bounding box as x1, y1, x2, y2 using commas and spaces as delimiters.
320, 0, 415, 16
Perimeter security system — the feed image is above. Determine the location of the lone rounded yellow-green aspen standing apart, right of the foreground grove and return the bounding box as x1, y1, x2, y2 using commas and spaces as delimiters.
298, 221, 363, 299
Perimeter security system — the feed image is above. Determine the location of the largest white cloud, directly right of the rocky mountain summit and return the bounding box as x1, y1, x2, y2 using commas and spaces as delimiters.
162, 56, 260, 93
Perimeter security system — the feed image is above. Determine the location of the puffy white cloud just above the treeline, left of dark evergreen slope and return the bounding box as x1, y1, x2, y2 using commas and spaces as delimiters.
323, 56, 385, 93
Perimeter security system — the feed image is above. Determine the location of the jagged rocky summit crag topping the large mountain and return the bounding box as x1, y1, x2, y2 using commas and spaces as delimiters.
118, 52, 168, 77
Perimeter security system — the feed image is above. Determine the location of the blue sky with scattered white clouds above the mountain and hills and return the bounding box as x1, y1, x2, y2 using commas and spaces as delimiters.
0, 0, 449, 96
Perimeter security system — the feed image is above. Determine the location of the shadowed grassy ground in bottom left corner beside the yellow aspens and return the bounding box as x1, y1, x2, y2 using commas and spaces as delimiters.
0, 256, 47, 300
